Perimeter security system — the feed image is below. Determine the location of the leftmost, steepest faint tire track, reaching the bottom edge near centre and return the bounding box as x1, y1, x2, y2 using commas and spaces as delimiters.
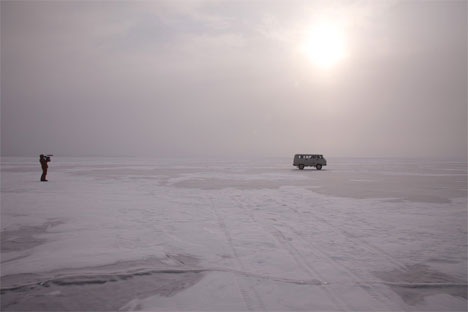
210, 197, 266, 311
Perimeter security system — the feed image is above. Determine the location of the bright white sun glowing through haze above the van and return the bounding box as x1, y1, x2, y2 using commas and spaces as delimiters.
301, 21, 348, 69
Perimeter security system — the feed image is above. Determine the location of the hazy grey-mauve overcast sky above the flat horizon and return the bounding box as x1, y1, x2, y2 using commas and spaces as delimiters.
0, 0, 468, 159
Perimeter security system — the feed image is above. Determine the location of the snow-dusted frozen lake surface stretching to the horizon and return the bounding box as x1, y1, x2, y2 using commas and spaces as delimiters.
1, 157, 467, 311
